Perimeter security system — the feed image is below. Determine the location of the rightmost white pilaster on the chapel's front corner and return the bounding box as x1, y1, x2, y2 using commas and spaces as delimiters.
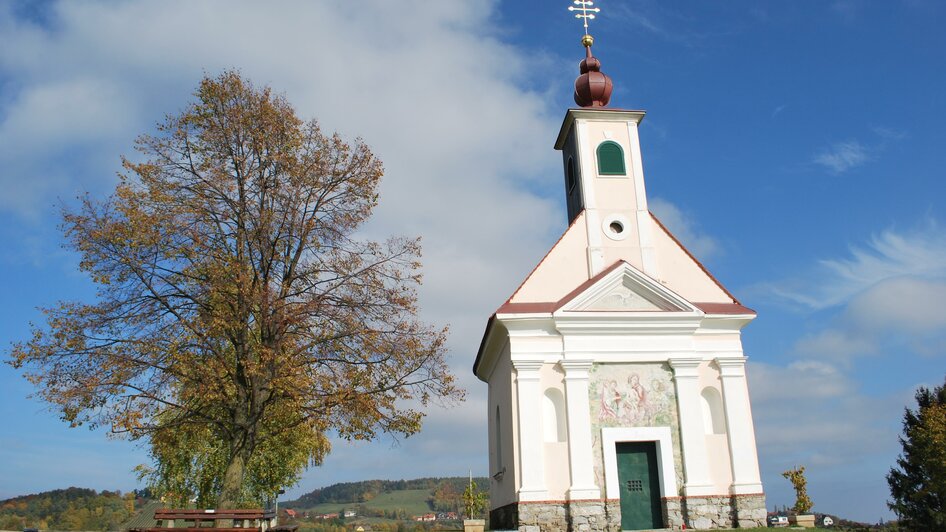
716, 357, 762, 495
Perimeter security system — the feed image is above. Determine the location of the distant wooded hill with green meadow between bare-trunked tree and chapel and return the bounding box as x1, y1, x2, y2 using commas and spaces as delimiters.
279, 477, 489, 518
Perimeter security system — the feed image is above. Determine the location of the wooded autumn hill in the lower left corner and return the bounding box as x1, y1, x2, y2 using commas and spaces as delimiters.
0, 488, 135, 531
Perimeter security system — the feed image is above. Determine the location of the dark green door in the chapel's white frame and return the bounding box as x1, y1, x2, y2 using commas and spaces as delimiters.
617, 441, 663, 530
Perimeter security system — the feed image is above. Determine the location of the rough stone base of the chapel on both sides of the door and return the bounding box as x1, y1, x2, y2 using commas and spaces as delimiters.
489, 493, 766, 532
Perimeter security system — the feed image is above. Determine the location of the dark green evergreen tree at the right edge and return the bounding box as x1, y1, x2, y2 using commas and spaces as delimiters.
887, 376, 946, 530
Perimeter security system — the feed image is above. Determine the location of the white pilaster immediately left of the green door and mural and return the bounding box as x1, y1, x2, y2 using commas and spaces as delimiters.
559, 360, 601, 500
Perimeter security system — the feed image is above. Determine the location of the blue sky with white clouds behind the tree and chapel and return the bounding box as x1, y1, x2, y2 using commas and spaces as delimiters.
0, 0, 946, 521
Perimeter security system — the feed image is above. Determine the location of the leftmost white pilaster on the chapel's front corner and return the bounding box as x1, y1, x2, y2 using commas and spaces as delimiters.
512, 360, 548, 501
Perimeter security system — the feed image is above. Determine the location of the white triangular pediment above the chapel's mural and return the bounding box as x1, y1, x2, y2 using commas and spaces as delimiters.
559, 262, 699, 312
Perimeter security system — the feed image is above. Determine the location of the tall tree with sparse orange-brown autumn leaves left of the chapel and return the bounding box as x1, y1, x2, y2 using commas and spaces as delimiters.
11, 72, 462, 507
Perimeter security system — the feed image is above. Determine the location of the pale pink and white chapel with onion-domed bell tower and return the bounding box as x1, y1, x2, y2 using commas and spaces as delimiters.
473, 29, 766, 532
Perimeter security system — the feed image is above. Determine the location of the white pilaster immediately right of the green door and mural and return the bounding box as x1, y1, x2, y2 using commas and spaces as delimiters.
670, 358, 714, 495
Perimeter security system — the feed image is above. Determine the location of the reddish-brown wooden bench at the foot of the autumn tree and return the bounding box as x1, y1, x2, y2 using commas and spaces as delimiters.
142, 509, 276, 532
